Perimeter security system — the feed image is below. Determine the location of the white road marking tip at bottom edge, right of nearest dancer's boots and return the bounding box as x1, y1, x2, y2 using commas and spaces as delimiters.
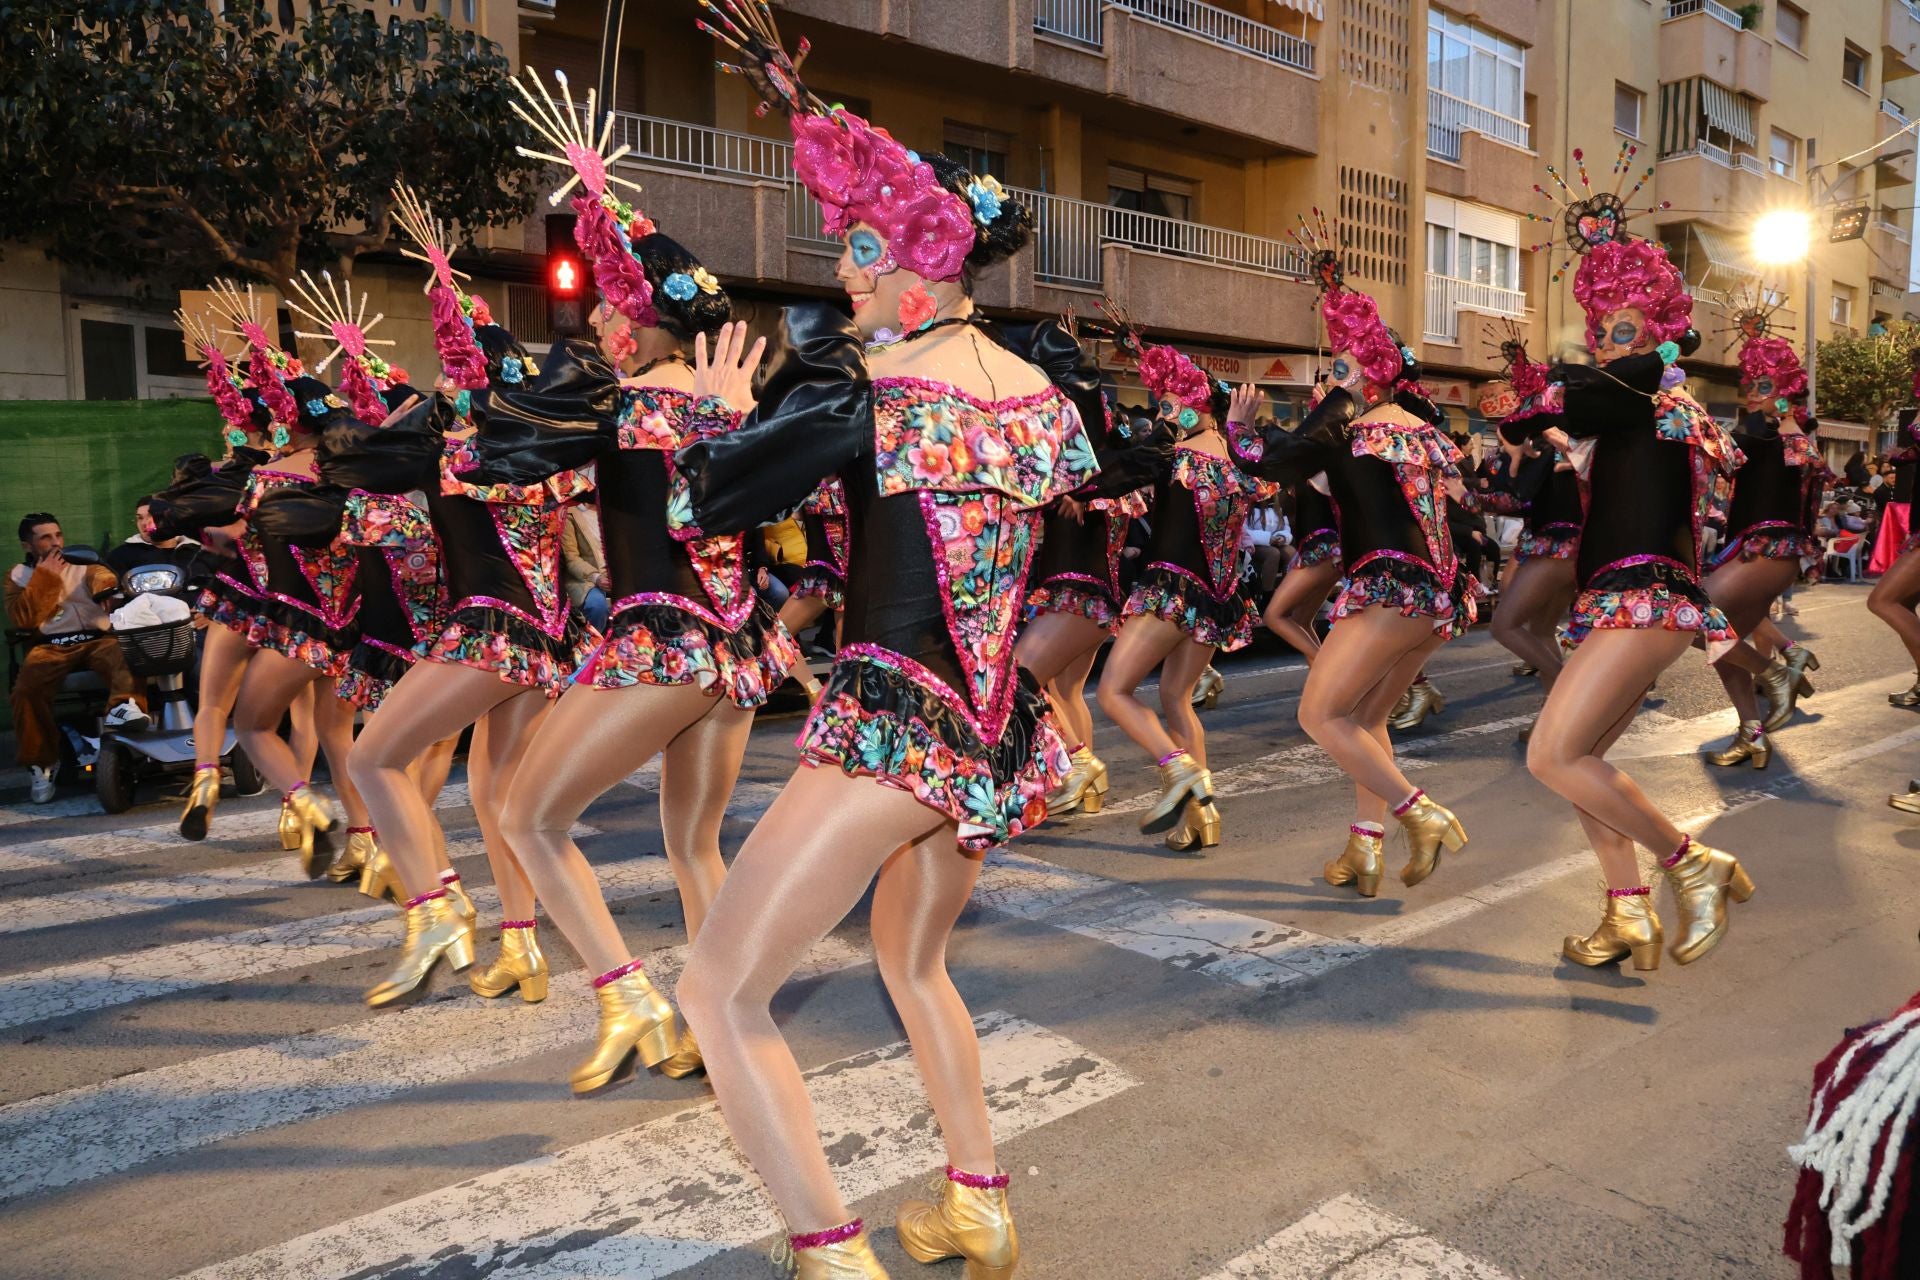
1202, 1196, 1513, 1280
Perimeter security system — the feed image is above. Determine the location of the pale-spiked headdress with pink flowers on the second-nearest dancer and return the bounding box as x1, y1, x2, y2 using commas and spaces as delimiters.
511, 67, 660, 328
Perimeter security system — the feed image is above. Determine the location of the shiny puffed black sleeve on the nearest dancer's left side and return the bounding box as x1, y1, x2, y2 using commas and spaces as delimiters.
674, 303, 874, 533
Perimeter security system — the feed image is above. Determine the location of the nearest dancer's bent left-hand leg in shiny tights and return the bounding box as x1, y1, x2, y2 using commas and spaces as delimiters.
676, 764, 952, 1232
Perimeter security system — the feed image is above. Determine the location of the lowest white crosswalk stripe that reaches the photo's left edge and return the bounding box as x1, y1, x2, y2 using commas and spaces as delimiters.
0, 936, 868, 1203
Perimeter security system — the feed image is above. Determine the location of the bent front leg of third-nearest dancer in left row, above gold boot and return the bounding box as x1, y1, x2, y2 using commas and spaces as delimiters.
348, 660, 526, 901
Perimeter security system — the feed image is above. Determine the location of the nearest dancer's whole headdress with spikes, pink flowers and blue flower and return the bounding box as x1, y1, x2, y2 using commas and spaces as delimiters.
699, 0, 983, 282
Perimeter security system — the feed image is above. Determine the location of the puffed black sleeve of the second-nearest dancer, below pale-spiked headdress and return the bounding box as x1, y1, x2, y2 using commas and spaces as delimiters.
461, 338, 622, 486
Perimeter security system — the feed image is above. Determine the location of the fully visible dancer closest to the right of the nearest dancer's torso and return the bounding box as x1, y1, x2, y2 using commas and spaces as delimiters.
1100, 311, 1275, 850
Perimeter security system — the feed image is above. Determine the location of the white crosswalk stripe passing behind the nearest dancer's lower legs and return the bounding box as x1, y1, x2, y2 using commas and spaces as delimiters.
182, 1011, 1139, 1280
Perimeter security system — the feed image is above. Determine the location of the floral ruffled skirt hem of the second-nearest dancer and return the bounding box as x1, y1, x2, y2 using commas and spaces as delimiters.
574, 599, 801, 706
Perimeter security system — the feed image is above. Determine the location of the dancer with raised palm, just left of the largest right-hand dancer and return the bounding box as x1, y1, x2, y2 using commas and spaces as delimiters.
1229, 209, 1478, 898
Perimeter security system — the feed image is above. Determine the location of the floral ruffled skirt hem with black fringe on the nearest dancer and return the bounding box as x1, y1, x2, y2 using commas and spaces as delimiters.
799, 645, 1071, 852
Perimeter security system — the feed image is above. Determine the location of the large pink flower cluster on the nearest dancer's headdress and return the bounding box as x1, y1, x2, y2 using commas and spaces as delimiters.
793, 109, 973, 280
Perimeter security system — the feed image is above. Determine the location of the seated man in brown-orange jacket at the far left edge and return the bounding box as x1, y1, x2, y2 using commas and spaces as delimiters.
6, 510, 152, 804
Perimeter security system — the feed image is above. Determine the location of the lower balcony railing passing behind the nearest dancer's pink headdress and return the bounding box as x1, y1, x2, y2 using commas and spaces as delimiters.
614, 111, 1308, 290
